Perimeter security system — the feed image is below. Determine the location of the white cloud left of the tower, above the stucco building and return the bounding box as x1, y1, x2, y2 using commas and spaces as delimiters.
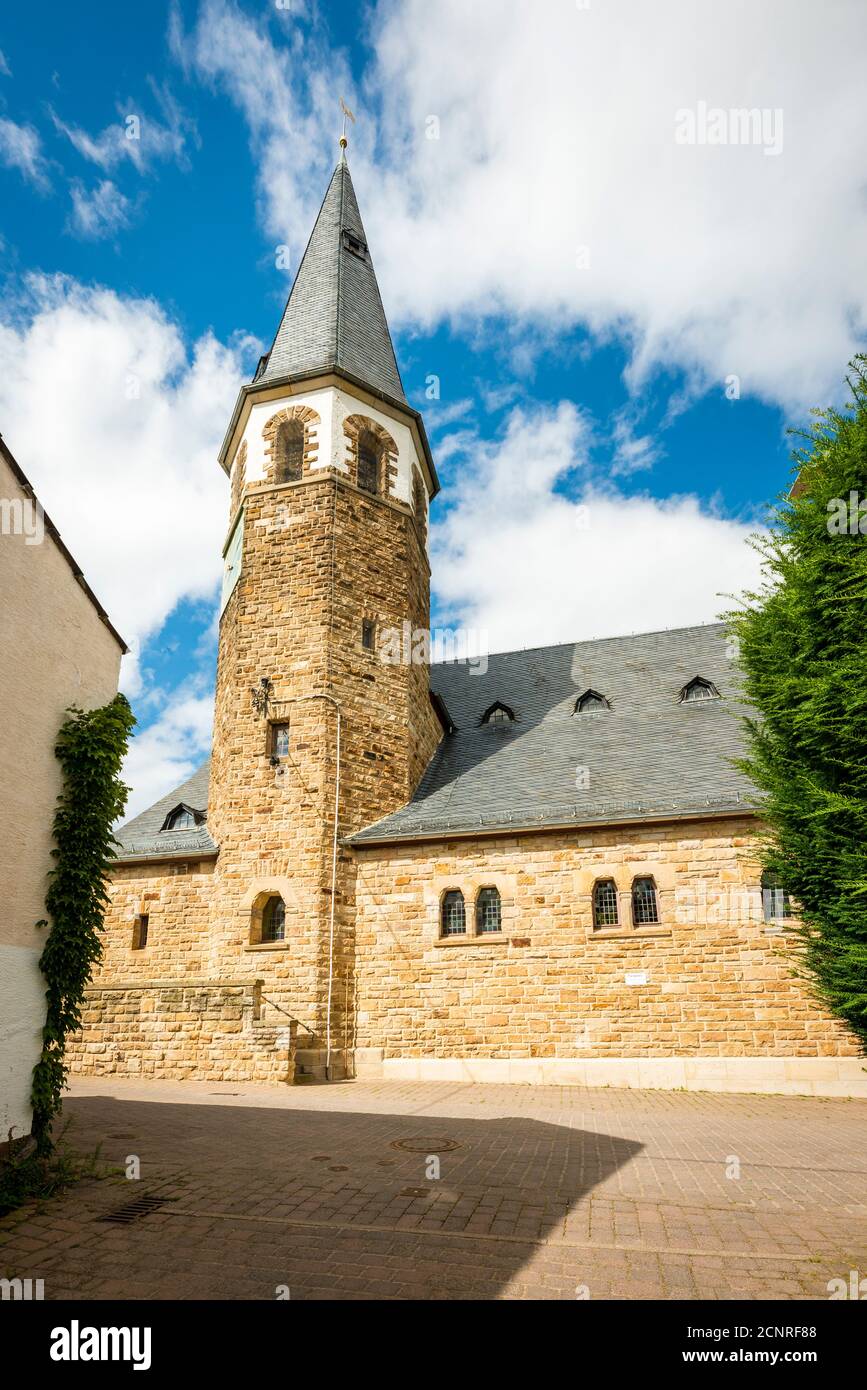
0, 277, 246, 688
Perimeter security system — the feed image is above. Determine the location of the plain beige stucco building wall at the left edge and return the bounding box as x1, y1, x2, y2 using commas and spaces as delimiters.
0, 441, 124, 1144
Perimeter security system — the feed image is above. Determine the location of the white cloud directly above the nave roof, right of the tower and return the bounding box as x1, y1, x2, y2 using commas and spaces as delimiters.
432, 402, 759, 651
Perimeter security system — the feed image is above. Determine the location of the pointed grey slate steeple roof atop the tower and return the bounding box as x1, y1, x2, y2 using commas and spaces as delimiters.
256, 153, 406, 403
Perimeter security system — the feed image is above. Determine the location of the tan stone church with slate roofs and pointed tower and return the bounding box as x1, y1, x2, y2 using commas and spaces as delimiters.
69, 152, 866, 1094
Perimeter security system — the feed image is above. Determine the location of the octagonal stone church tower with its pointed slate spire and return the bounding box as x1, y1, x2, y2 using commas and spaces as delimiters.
208, 153, 440, 1076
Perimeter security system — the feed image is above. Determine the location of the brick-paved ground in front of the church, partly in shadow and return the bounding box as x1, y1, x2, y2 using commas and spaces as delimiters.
0, 1079, 867, 1298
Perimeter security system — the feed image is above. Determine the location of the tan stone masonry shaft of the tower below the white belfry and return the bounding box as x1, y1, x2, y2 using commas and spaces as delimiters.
203, 471, 440, 1054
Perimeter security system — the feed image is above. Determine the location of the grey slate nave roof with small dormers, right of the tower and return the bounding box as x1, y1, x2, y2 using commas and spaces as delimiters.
350, 623, 754, 845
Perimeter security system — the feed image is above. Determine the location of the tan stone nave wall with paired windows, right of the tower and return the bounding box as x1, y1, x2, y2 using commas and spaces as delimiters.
348, 819, 859, 1058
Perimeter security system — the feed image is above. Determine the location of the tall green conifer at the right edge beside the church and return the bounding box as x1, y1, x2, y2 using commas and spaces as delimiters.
727, 357, 867, 1043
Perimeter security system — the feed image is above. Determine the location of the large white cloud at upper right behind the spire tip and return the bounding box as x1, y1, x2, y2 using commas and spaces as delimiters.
175, 0, 867, 407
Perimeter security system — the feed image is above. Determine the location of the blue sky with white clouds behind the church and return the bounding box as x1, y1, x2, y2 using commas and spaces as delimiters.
0, 0, 867, 808
